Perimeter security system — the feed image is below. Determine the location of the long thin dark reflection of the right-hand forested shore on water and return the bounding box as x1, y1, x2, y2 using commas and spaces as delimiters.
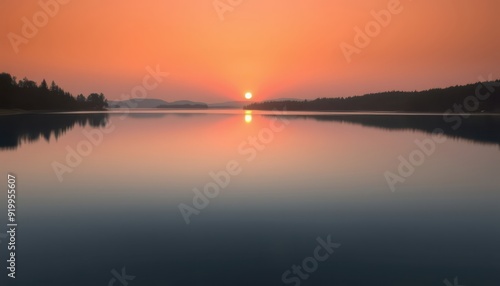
270, 114, 500, 145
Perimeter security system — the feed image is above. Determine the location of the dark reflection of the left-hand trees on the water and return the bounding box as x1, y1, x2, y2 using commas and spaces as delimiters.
0, 113, 108, 149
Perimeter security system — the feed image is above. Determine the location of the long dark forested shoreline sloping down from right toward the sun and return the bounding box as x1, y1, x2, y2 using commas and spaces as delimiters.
244, 80, 500, 113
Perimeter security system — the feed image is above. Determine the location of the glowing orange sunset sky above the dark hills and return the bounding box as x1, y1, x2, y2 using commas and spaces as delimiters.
0, 0, 500, 103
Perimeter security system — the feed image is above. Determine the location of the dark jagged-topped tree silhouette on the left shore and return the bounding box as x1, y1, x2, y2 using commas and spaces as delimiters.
0, 73, 108, 111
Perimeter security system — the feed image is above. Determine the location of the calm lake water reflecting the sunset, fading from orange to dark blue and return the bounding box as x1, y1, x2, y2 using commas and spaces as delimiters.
0, 110, 500, 286
